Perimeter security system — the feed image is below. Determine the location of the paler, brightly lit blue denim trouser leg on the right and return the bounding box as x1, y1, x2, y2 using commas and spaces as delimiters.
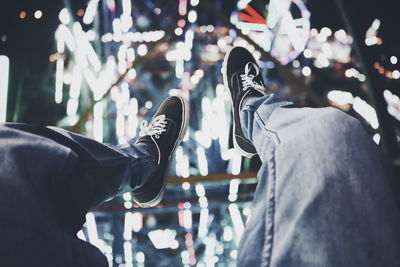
238, 95, 400, 267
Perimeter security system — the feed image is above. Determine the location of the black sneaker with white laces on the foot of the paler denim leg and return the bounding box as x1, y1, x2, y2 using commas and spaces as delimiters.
222, 47, 266, 158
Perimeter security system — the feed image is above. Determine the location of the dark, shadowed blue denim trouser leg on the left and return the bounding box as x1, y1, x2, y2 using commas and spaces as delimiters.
0, 124, 156, 267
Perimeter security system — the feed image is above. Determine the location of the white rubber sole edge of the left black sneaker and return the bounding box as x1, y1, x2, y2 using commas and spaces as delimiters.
137, 95, 190, 208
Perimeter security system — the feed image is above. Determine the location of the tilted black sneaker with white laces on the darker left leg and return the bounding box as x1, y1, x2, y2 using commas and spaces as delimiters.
132, 96, 189, 208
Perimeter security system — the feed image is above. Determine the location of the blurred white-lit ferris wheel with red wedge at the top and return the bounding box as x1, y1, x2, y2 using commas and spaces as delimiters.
231, 0, 310, 65
